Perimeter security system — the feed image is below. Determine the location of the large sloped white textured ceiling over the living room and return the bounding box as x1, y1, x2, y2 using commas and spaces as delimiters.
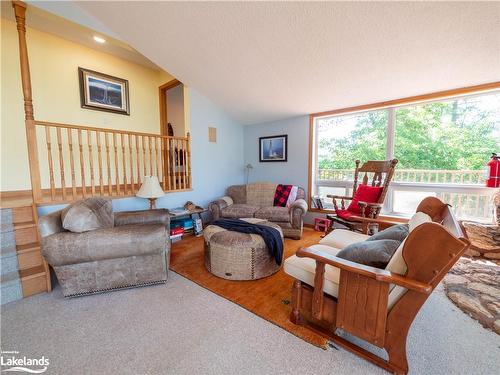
22, 2, 500, 124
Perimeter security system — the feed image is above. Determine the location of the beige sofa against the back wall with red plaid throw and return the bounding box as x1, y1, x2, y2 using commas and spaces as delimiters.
208, 182, 307, 239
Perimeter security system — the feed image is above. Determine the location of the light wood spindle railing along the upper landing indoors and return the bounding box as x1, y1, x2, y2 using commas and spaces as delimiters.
27, 121, 192, 203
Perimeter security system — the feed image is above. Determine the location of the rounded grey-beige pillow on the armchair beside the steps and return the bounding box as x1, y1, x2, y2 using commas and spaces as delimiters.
61, 197, 114, 233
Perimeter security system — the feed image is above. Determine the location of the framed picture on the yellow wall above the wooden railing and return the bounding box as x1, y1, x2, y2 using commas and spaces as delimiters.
78, 68, 130, 115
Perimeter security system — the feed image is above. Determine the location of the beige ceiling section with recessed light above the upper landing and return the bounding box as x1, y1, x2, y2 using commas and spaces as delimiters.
0, 1, 160, 69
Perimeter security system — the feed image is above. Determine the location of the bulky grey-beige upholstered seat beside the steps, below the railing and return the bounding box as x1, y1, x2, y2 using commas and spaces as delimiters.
39, 198, 170, 297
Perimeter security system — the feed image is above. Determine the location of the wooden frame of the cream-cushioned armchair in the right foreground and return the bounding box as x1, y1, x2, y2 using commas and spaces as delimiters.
285, 197, 470, 374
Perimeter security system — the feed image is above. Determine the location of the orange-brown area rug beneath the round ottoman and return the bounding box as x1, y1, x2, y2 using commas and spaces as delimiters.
170, 229, 327, 348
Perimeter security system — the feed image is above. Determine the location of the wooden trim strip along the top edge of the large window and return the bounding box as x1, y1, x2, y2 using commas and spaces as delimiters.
310, 81, 500, 118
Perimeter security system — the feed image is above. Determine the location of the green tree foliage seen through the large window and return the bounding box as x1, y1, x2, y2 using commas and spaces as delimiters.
318, 94, 500, 170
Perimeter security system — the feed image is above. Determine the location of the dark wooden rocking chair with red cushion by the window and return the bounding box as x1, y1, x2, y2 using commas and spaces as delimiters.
327, 159, 398, 230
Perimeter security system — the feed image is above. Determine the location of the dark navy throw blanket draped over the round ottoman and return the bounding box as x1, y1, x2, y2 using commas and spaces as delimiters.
212, 219, 283, 265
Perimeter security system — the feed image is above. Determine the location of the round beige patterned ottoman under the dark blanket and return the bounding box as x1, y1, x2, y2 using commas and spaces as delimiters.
203, 219, 283, 280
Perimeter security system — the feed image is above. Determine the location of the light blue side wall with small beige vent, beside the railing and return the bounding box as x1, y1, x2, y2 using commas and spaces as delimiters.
38, 88, 244, 215
